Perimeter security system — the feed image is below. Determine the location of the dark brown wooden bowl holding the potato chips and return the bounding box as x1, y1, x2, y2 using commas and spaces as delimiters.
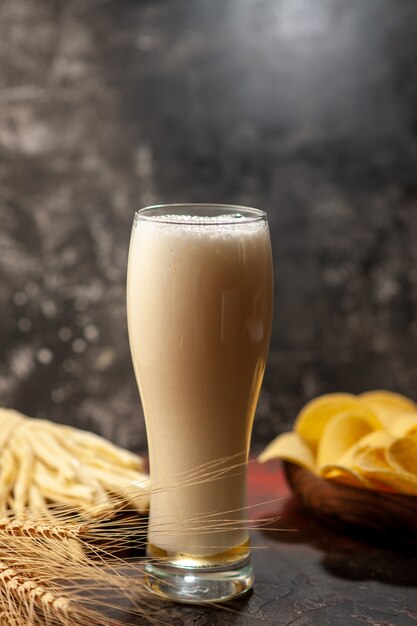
284, 461, 417, 545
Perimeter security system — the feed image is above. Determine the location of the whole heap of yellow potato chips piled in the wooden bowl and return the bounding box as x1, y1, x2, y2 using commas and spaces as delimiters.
260, 390, 417, 495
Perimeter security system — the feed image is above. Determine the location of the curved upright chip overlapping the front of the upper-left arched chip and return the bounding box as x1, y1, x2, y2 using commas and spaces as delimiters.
317, 407, 380, 468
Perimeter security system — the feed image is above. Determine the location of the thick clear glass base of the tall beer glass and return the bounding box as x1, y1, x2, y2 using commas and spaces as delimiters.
145, 561, 254, 604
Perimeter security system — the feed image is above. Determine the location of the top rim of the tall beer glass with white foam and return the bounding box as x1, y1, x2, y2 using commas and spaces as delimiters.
135, 202, 267, 227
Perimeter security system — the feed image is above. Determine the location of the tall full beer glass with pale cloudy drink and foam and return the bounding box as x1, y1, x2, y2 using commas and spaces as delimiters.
127, 204, 273, 603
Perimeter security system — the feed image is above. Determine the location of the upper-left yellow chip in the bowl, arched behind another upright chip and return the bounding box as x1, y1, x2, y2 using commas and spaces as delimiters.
294, 393, 360, 453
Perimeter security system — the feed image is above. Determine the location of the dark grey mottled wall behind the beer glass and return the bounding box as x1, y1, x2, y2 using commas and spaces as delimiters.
0, 0, 417, 450
